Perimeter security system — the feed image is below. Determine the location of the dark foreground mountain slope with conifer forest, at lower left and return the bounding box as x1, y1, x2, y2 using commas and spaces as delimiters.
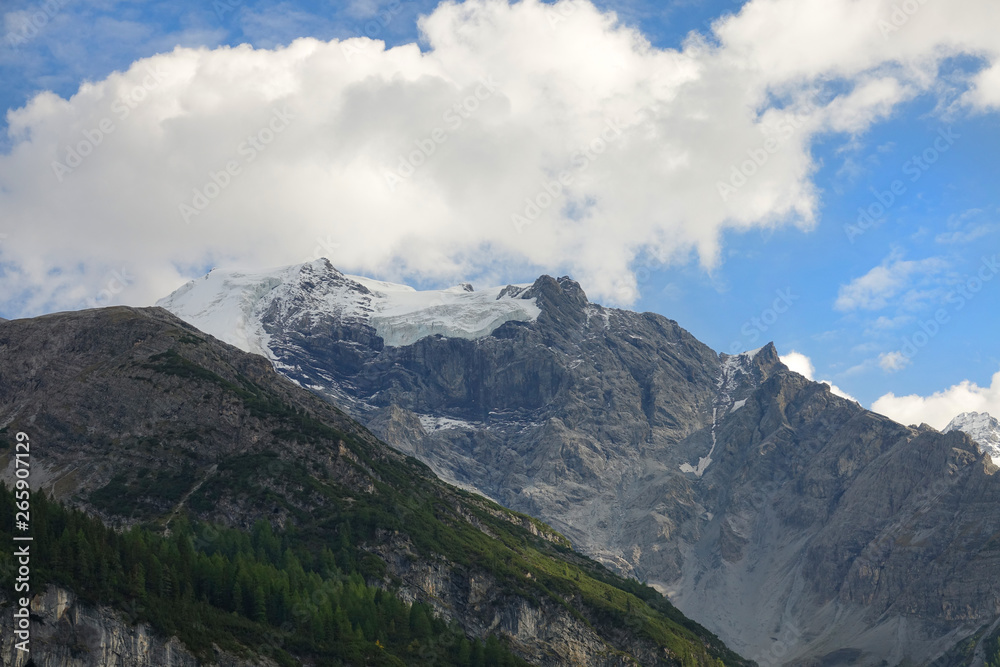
0, 307, 748, 667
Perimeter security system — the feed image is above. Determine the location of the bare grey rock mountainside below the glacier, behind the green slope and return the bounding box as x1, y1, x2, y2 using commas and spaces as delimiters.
158, 267, 1000, 665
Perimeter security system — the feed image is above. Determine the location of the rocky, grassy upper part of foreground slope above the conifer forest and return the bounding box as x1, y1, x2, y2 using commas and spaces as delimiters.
0, 308, 744, 666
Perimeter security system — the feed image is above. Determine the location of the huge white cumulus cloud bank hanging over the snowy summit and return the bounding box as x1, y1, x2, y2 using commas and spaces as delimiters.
0, 0, 1000, 314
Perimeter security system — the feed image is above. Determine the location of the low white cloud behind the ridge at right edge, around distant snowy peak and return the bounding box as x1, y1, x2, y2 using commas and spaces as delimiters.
871, 372, 1000, 430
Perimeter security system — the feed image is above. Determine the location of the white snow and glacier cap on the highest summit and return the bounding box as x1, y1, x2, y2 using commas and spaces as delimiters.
156, 259, 541, 359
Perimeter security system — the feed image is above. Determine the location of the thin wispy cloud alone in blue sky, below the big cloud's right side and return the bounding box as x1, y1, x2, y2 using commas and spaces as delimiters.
834, 252, 947, 311
